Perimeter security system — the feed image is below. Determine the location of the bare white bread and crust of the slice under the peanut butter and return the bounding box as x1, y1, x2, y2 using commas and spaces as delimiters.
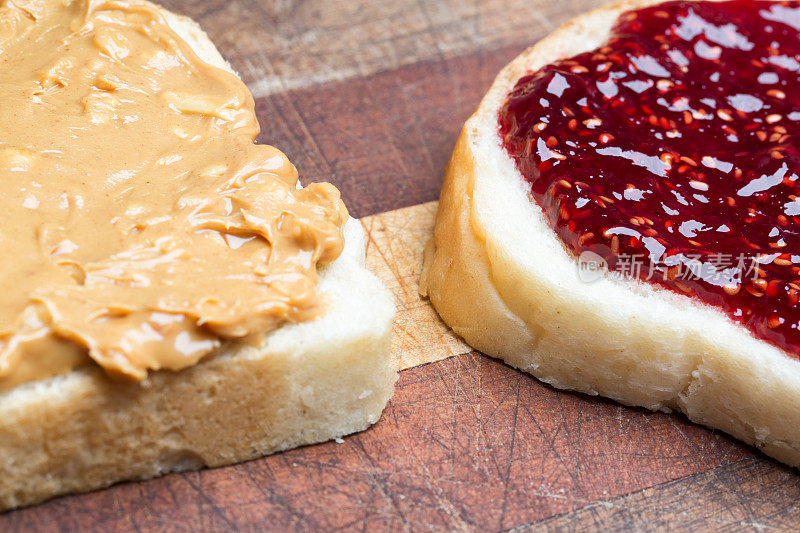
0, 5, 397, 510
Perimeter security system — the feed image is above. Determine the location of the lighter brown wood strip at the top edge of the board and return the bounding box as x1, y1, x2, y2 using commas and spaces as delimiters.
162, 0, 601, 97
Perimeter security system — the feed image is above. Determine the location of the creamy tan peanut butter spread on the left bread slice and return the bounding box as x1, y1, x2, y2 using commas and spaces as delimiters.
0, 0, 347, 390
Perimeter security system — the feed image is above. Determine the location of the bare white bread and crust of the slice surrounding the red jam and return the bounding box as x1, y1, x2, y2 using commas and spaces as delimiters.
421, 0, 800, 466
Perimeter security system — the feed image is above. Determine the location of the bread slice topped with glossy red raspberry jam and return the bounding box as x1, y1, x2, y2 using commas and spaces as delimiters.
421, 0, 800, 466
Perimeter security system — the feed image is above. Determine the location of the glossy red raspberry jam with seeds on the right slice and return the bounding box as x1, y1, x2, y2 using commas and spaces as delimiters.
499, 0, 800, 357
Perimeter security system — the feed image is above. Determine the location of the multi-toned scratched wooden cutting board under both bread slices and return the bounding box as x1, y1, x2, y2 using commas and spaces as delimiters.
6, 0, 800, 531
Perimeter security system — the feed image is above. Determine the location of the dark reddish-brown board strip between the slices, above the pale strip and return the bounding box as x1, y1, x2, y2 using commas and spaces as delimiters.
256, 42, 523, 218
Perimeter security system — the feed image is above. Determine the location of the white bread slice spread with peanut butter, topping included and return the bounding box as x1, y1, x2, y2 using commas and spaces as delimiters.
0, 0, 396, 509
